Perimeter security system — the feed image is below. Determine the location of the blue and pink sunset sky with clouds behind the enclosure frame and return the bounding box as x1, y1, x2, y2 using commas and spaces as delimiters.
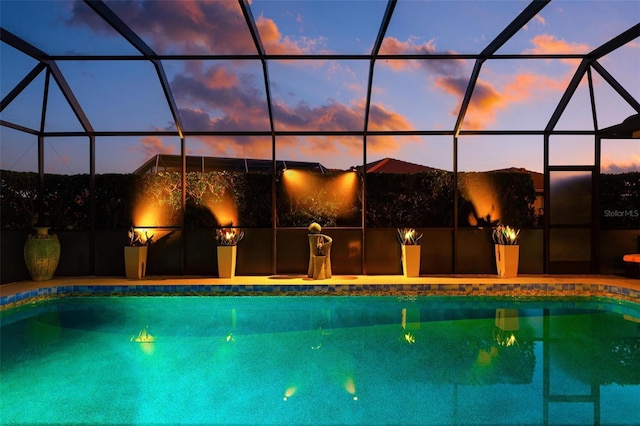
0, 0, 640, 174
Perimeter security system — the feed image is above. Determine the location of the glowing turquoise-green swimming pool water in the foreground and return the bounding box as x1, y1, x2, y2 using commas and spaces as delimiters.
0, 296, 640, 425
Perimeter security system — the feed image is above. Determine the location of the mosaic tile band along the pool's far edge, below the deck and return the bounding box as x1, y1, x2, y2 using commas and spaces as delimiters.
0, 283, 640, 310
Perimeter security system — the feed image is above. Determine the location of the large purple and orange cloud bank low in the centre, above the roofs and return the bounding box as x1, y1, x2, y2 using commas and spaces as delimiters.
171, 60, 417, 161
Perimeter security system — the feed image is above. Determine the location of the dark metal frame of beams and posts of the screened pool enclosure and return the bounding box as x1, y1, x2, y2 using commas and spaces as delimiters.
0, 0, 640, 273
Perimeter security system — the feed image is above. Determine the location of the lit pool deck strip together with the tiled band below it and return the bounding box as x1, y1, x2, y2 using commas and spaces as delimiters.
0, 274, 640, 309
